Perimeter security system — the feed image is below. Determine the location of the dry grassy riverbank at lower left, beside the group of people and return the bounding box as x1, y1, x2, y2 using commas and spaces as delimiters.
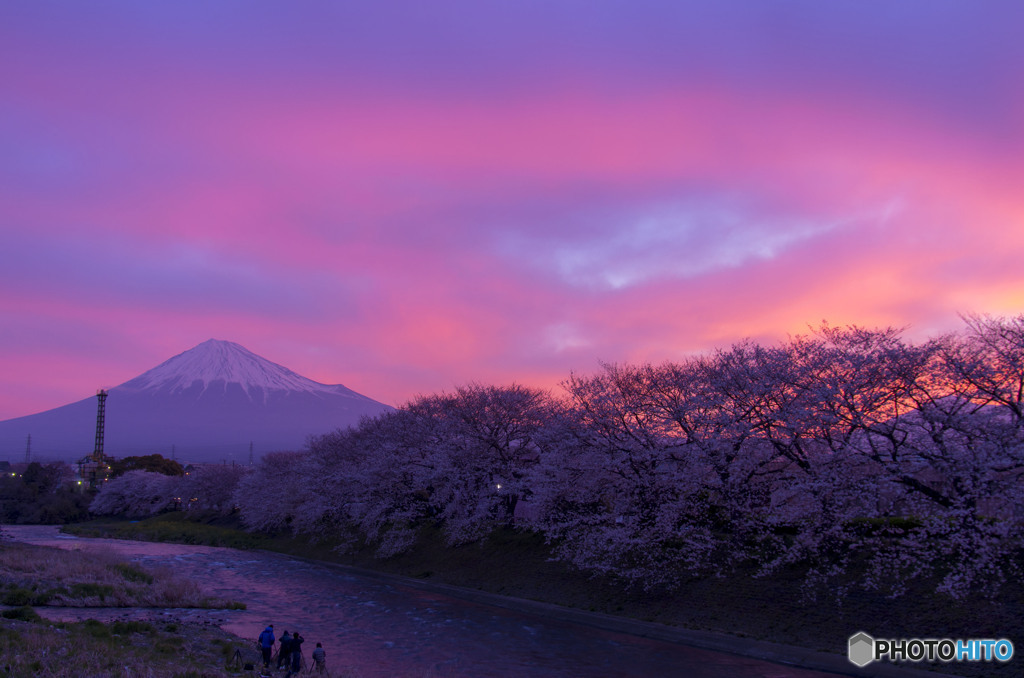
0, 541, 253, 678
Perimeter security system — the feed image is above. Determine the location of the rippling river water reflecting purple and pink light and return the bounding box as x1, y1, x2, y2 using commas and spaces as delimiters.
3, 525, 835, 678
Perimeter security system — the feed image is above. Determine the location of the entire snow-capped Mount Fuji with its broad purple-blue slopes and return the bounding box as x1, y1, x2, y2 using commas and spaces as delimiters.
0, 339, 391, 463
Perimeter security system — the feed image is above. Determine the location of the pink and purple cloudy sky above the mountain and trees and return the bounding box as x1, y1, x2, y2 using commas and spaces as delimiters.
0, 0, 1024, 419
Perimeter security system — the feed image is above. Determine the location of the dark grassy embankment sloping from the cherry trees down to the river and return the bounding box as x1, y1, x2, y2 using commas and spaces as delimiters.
61, 514, 1024, 676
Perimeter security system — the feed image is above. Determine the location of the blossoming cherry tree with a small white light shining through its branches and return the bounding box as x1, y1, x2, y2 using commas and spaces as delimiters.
329, 385, 549, 555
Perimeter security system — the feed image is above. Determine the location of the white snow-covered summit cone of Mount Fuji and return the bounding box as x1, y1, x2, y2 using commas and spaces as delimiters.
121, 339, 347, 393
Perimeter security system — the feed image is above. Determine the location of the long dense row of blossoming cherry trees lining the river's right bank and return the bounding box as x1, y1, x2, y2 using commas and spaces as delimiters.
93, 315, 1024, 597
